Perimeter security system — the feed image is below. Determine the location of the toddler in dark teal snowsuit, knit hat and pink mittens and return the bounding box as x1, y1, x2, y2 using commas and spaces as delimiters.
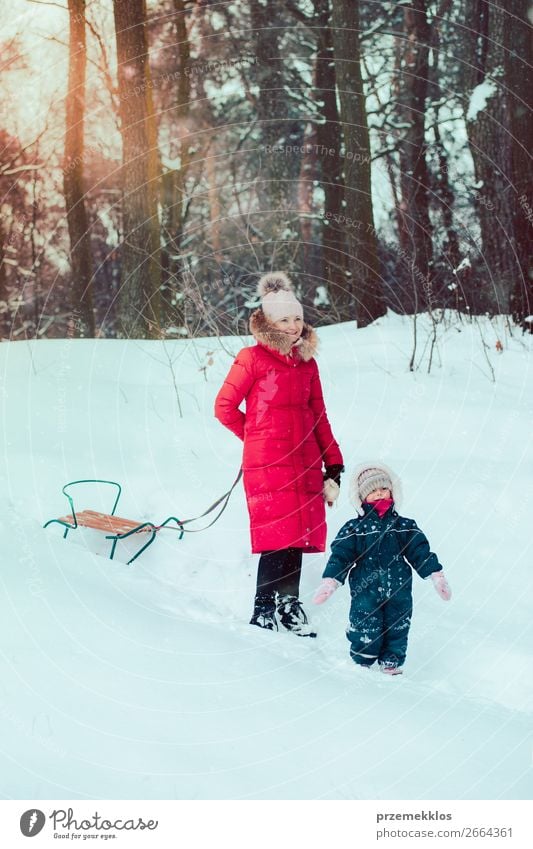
313, 464, 451, 675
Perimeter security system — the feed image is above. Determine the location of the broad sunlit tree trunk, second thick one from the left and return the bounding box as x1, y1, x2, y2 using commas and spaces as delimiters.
113, 0, 160, 338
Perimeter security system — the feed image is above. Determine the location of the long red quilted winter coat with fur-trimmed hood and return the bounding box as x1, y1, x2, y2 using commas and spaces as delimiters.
215, 310, 342, 553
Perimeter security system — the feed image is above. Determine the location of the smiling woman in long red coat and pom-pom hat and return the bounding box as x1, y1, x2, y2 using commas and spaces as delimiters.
215, 272, 344, 636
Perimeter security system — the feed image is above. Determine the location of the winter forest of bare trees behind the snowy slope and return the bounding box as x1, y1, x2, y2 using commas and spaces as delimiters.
0, 0, 533, 340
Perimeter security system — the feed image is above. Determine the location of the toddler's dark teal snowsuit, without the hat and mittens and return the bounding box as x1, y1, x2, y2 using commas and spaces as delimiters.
323, 503, 442, 666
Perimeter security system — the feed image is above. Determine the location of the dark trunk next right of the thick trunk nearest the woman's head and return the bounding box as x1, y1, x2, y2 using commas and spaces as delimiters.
398, 0, 433, 312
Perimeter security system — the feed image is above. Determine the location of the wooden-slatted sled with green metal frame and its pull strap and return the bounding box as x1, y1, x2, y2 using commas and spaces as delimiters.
43, 470, 242, 566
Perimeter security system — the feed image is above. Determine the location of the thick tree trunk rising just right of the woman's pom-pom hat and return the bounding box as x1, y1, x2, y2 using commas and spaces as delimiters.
331, 0, 385, 327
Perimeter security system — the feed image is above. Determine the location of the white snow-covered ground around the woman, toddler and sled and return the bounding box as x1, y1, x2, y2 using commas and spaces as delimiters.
0, 315, 533, 799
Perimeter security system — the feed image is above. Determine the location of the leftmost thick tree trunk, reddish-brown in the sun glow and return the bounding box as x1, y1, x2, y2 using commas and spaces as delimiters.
63, 0, 94, 336
